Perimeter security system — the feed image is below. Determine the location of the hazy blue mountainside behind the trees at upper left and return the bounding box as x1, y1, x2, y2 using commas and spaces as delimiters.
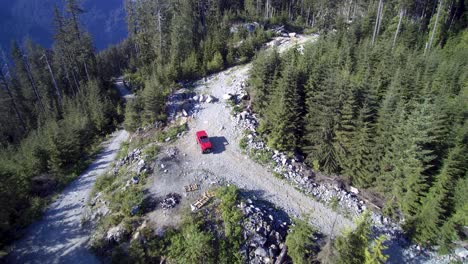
0, 0, 127, 50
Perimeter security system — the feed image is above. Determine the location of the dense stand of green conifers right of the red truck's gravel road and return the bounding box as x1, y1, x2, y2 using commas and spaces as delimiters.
250, 8, 468, 248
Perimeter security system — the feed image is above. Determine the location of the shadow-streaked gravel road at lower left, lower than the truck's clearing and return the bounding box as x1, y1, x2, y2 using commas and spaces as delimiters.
7, 130, 129, 264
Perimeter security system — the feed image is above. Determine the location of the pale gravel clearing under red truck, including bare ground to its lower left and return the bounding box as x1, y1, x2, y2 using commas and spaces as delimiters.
150, 65, 352, 234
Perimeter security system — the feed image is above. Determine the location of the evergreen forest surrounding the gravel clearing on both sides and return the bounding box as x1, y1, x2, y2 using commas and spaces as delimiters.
0, 0, 468, 263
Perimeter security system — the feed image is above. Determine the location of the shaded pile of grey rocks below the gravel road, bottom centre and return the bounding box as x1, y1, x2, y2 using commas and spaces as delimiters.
239, 199, 289, 263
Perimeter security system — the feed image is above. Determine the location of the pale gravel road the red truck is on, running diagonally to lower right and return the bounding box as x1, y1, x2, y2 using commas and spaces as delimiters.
166, 64, 352, 234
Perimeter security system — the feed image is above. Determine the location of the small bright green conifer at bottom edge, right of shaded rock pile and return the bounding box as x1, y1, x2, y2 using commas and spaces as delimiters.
286, 219, 317, 264
